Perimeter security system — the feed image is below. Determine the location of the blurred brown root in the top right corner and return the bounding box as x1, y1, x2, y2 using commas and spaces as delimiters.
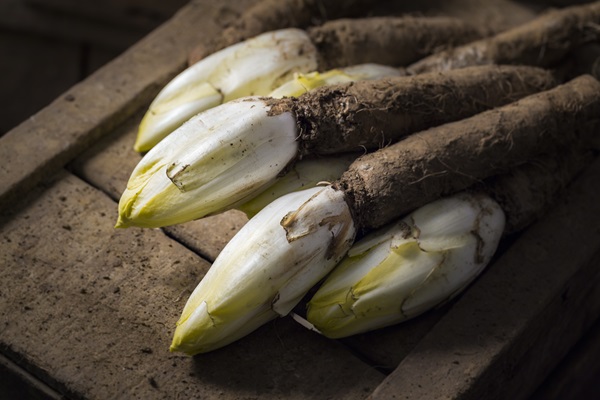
407, 2, 600, 74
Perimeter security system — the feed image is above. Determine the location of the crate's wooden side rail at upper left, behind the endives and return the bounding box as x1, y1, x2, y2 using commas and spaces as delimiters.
0, 1, 255, 209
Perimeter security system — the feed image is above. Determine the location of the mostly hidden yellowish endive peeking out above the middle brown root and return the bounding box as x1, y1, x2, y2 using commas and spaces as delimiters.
269, 64, 401, 98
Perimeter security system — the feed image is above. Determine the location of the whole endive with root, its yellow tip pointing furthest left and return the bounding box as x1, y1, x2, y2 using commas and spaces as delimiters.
117, 65, 554, 227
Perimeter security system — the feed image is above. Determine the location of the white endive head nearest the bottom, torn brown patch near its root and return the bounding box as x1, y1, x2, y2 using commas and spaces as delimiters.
171, 188, 355, 355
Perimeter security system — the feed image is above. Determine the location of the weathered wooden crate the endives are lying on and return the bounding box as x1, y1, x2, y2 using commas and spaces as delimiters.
0, 0, 600, 399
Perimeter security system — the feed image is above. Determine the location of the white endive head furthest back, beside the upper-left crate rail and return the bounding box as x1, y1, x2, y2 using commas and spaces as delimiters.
134, 28, 317, 152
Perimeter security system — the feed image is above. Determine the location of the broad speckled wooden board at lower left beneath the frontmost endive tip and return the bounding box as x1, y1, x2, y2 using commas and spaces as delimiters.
0, 173, 384, 399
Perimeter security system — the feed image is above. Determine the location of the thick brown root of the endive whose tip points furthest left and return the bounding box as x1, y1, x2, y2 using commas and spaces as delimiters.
271, 66, 555, 156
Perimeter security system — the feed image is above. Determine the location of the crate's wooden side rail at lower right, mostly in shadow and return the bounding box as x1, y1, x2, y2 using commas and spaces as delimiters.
372, 155, 600, 399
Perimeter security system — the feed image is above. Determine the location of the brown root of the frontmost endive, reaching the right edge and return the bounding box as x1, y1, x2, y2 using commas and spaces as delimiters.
333, 75, 600, 230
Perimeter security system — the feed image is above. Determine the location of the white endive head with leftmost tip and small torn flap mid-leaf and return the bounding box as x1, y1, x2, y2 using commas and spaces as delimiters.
117, 98, 298, 227
